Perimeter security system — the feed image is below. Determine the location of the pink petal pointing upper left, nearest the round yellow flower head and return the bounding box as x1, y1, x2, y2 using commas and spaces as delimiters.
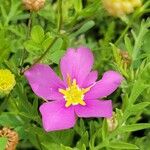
25, 64, 64, 100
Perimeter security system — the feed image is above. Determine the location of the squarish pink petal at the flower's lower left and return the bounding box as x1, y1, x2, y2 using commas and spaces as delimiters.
40, 100, 76, 132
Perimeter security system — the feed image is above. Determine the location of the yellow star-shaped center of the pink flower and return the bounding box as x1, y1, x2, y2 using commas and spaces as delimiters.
59, 76, 91, 107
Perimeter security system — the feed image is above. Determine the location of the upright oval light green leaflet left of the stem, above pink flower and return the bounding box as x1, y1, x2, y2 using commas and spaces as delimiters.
31, 25, 44, 43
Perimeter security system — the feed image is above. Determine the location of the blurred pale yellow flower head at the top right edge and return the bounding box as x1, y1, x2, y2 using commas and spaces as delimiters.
103, 0, 142, 17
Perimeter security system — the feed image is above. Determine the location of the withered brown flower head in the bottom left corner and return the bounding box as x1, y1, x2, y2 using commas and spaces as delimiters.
0, 127, 19, 150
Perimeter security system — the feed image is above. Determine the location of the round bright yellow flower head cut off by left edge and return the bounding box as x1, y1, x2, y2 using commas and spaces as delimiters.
0, 69, 16, 96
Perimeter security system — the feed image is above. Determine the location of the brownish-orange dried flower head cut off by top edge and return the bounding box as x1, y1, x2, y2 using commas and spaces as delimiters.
23, 0, 45, 11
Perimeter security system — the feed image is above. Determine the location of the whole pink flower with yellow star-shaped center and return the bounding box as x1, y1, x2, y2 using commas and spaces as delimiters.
25, 47, 123, 131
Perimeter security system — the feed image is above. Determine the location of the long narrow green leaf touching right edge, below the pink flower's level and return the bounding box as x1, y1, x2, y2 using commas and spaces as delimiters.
119, 123, 150, 133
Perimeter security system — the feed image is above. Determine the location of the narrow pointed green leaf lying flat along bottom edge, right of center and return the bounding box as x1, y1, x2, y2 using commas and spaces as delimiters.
108, 141, 139, 150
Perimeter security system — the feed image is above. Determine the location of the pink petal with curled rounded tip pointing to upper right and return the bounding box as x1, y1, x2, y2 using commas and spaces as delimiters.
85, 71, 123, 99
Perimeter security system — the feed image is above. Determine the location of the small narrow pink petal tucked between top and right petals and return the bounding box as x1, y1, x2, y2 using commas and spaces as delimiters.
82, 71, 98, 88
